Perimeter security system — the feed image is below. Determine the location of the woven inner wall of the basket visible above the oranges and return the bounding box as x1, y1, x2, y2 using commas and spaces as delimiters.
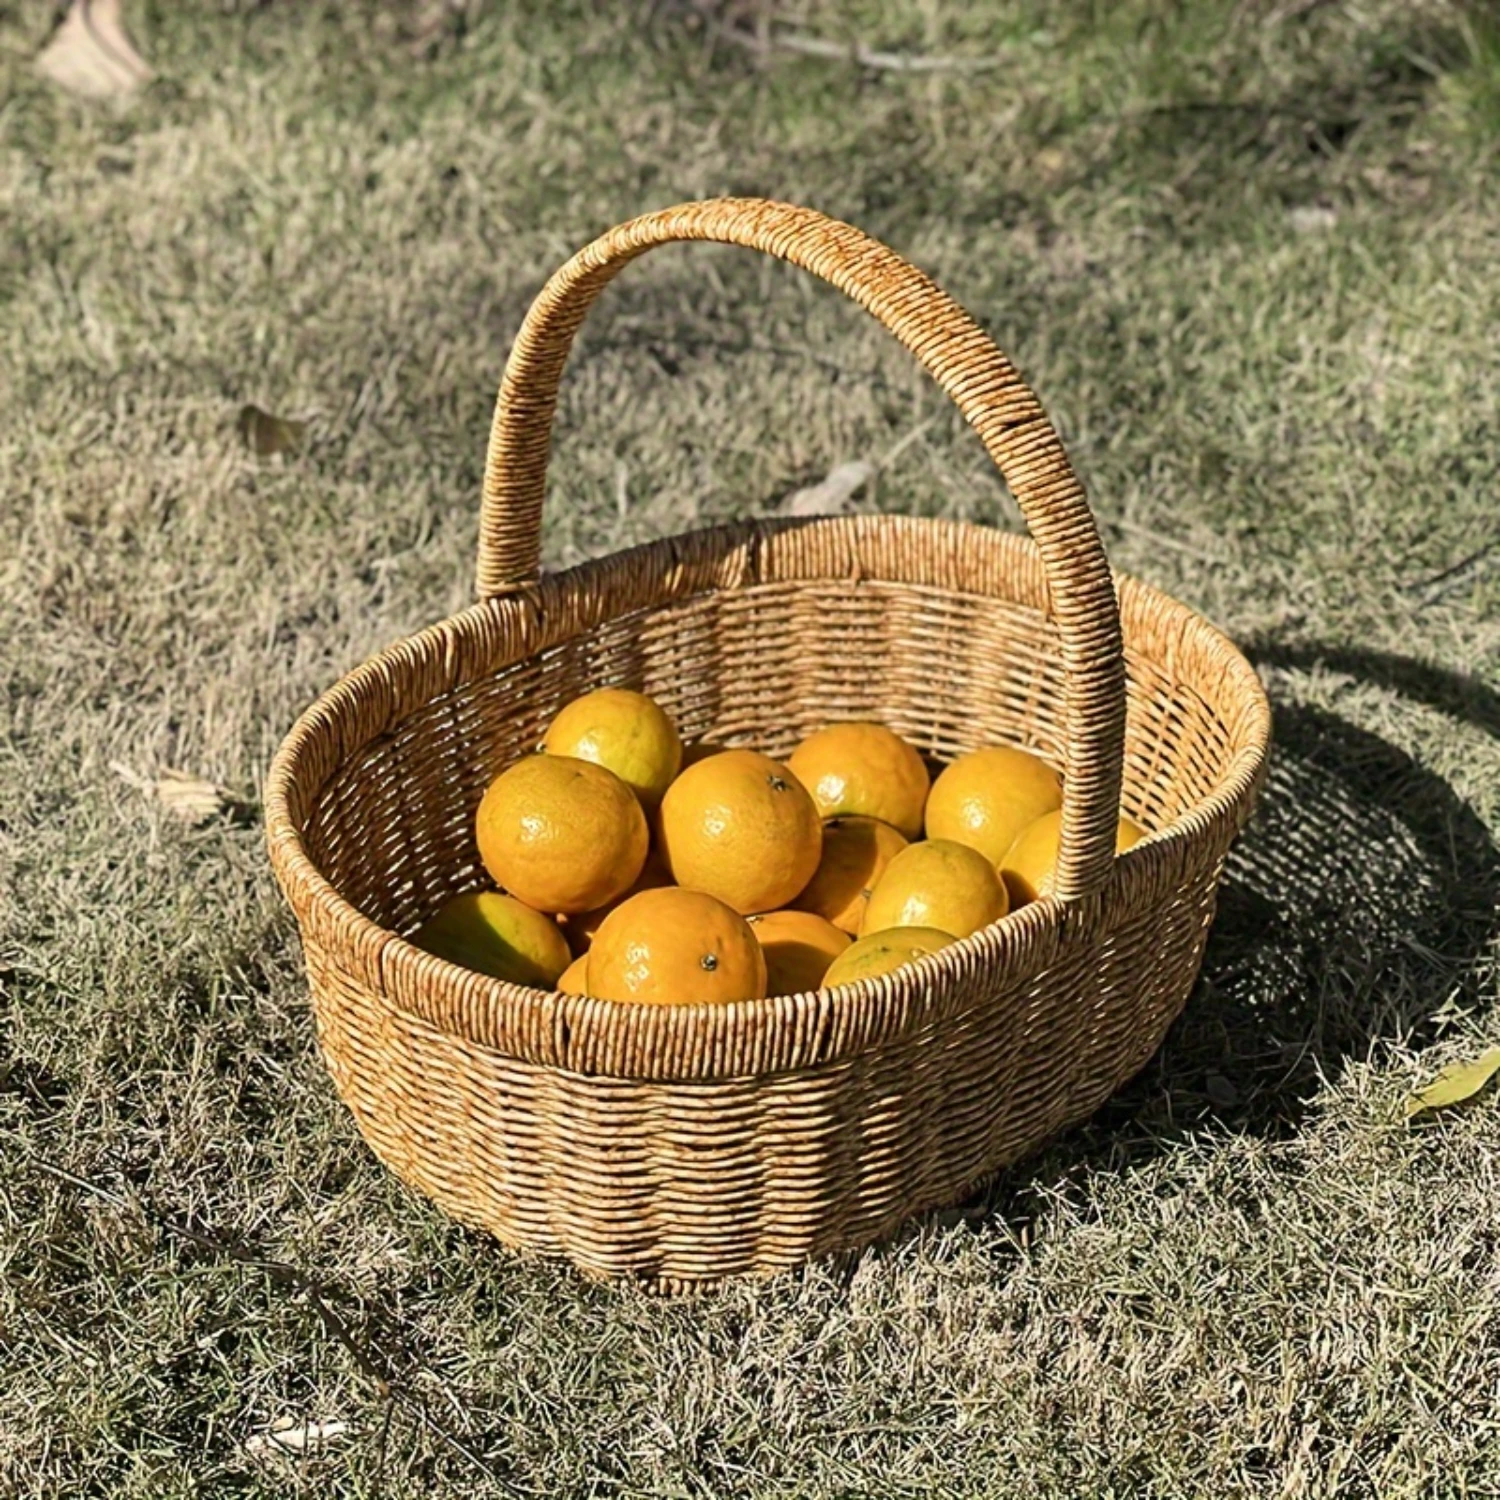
305, 578, 1248, 933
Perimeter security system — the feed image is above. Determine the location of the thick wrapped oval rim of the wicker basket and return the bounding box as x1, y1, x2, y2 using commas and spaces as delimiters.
264, 516, 1271, 1083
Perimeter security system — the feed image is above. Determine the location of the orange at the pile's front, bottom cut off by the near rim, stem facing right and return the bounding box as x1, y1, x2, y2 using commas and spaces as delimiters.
588, 887, 765, 1005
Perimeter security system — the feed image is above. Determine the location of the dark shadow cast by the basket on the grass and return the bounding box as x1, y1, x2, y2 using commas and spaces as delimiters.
927, 647, 1500, 1242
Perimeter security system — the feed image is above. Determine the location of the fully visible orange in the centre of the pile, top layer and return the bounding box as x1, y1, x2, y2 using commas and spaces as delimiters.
659, 750, 824, 914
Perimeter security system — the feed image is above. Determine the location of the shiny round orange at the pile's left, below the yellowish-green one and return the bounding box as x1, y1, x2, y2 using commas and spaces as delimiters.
474, 755, 648, 912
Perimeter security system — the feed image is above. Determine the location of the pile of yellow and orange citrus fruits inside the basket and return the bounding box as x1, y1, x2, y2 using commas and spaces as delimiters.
411, 687, 1145, 1005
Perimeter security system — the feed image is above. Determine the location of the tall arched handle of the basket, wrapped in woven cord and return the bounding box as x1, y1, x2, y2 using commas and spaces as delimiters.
479, 198, 1125, 900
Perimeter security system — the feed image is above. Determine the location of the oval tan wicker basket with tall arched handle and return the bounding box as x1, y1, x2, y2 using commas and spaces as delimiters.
266, 200, 1271, 1286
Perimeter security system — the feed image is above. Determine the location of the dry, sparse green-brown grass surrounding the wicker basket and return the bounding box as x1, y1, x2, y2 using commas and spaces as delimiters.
0, 0, 1500, 1500
